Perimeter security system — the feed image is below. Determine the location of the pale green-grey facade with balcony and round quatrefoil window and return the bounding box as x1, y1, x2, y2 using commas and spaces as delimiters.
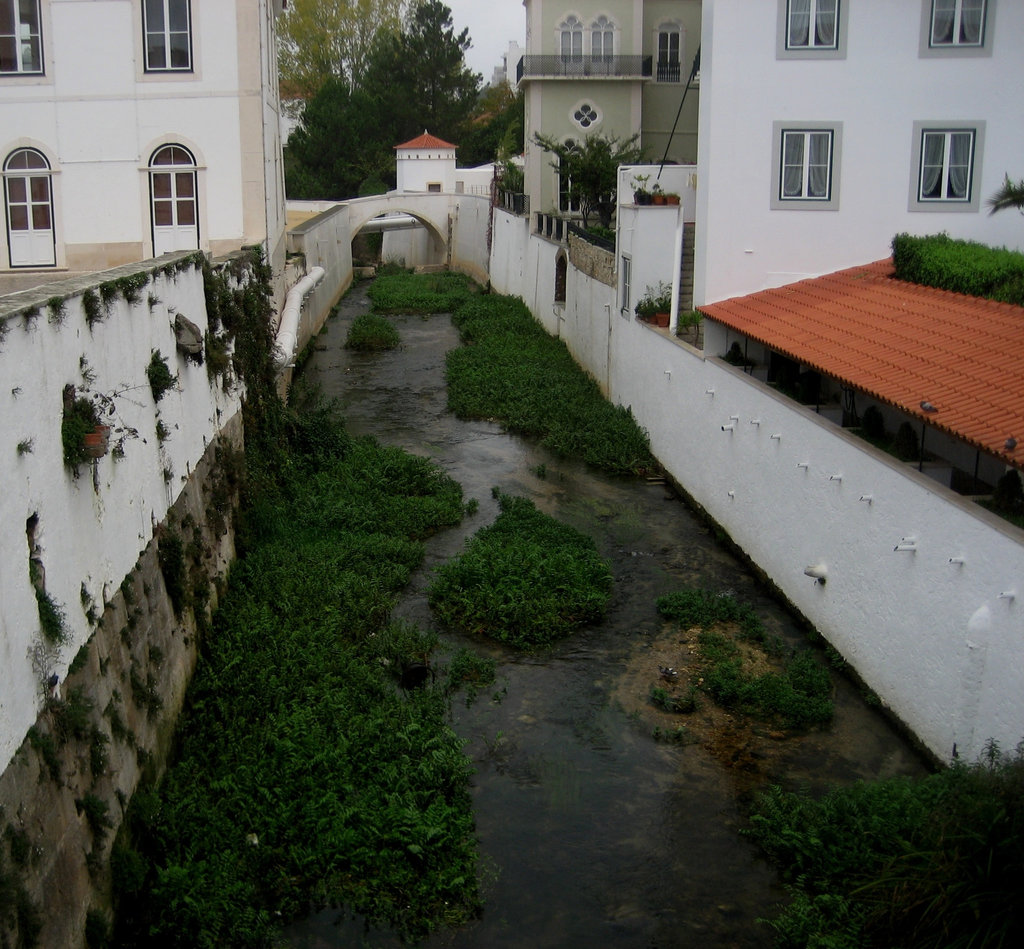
518, 0, 700, 212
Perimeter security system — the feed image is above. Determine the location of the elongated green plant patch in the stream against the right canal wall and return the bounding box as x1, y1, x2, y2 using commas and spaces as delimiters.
445, 294, 655, 474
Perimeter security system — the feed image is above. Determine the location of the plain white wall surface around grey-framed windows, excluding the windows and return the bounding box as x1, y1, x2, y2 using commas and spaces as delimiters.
694, 0, 1024, 303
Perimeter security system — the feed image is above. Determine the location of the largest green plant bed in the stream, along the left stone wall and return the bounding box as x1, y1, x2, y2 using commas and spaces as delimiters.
118, 397, 479, 946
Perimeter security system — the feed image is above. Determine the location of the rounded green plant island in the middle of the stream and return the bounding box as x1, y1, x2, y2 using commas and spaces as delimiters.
427, 491, 611, 649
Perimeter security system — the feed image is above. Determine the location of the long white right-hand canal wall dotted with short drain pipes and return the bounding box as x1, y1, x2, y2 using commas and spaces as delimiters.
492, 211, 1024, 760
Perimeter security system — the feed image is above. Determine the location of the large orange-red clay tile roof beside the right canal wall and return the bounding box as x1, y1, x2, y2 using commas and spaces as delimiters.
699, 260, 1024, 467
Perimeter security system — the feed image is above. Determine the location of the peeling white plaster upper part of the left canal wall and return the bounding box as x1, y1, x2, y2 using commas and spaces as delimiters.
0, 257, 241, 770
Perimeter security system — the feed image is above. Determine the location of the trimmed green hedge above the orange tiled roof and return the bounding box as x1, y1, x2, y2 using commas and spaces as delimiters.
893, 233, 1024, 306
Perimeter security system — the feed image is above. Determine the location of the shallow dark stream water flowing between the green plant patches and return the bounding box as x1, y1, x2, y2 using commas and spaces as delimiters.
286, 289, 925, 949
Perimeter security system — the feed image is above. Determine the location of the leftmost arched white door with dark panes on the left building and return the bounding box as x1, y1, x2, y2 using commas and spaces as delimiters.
3, 148, 56, 267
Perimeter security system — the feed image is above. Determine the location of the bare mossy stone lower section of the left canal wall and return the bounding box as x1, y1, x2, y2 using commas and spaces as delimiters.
0, 414, 243, 949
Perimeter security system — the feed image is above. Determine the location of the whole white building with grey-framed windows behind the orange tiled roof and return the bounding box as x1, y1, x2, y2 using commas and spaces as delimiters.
694, 0, 1024, 303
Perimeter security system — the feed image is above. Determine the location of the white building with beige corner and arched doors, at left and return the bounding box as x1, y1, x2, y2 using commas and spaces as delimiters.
0, 0, 285, 271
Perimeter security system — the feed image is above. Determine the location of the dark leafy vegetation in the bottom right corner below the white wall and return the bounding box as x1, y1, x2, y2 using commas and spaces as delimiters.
748, 745, 1024, 949
